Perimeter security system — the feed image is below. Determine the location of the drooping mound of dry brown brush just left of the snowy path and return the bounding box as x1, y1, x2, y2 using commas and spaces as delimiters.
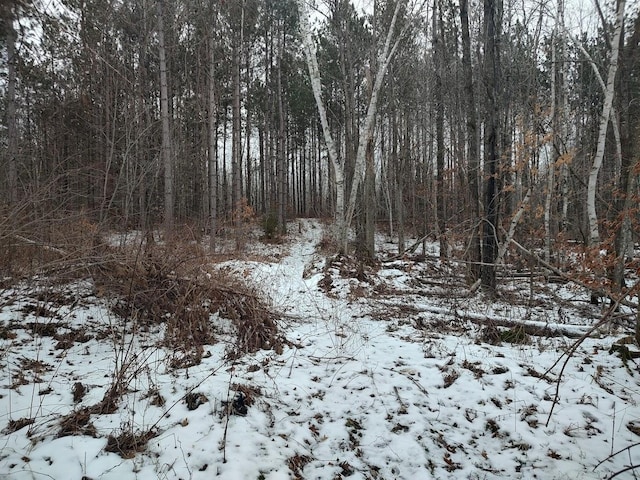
94, 240, 283, 360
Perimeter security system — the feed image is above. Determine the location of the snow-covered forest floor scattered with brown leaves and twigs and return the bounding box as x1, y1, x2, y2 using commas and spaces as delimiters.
0, 220, 640, 480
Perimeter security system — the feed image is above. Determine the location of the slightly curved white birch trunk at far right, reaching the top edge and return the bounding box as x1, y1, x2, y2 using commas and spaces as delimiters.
587, 0, 625, 246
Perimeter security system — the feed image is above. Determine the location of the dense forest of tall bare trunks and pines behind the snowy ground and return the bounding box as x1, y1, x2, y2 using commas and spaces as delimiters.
0, 0, 640, 291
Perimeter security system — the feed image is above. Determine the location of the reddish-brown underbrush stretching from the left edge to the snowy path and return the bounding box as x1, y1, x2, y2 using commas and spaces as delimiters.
0, 212, 283, 367
